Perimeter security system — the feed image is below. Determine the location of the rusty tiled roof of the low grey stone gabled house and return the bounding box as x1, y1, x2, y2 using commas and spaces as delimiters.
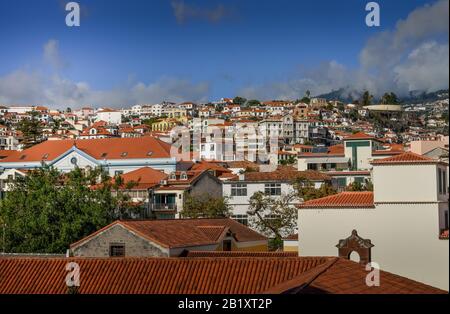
70, 218, 267, 248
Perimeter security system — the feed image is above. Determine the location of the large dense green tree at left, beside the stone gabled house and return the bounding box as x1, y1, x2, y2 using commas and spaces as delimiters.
0, 167, 139, 253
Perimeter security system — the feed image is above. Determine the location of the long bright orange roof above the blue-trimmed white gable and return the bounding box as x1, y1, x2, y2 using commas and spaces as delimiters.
1, 136, 170, 162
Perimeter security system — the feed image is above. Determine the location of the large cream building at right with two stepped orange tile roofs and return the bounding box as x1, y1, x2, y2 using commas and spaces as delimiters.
298, 152, 449, 290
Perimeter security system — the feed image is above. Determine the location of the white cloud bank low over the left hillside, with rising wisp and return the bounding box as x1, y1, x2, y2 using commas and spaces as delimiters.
0, 40, 209, 108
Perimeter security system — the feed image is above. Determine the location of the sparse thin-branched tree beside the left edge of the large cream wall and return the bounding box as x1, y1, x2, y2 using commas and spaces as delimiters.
247, 192, 297, 250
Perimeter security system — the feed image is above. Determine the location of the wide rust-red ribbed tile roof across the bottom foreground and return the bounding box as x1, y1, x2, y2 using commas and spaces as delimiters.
0, 257, 447, 294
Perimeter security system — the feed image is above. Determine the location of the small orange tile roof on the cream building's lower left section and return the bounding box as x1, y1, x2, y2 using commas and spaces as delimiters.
298, 192, 374, 208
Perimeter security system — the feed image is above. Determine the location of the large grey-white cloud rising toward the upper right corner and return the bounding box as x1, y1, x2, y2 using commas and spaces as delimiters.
238, 0, 449, 99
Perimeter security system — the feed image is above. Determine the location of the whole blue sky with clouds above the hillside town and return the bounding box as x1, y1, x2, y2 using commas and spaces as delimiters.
0, 0, 448, 106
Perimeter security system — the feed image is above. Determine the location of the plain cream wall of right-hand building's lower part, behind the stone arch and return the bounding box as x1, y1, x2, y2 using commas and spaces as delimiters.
298, 204, 449, 290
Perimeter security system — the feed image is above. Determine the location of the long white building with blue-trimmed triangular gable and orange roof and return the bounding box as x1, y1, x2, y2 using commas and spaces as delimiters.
0, 136, 176, 176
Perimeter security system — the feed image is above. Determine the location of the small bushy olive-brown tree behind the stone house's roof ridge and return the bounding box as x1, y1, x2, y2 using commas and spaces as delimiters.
180, 193, 231, 218
